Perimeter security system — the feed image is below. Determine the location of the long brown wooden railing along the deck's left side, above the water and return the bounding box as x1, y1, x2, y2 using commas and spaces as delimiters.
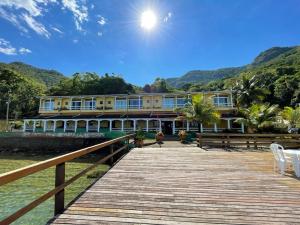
0, 134, 134, 225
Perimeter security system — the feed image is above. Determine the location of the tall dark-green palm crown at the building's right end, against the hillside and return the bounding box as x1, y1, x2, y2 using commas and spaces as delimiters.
233, 74, 270, 107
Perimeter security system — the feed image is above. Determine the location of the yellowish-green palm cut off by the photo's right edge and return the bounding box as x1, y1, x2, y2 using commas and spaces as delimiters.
279, 106, 300, 132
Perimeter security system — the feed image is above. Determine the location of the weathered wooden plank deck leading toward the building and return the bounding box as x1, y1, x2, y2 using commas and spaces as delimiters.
53, 147, 300, 225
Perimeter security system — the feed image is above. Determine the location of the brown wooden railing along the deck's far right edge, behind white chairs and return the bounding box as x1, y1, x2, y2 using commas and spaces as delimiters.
197, 133, 300, 149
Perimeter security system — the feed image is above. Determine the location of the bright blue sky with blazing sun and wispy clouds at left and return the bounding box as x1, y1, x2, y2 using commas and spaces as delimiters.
0, 0, 300, 86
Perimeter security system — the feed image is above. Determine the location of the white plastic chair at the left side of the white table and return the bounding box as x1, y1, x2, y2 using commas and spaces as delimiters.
270, 144, 292, 175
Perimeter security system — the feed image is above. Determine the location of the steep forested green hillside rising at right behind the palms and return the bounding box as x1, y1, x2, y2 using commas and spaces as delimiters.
189, 46, 300, 106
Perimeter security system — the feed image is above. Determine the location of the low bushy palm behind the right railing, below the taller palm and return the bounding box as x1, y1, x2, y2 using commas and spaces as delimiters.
235, 104, 279, 133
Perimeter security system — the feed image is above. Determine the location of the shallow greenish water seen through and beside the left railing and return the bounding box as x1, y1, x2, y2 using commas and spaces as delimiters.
0, 154, 109, 225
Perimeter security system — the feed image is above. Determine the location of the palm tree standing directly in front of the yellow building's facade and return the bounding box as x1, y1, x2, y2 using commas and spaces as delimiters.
175, 95, 220, 132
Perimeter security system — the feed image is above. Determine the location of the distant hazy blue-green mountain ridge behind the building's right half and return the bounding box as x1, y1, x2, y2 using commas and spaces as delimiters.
166, 67, 245, 88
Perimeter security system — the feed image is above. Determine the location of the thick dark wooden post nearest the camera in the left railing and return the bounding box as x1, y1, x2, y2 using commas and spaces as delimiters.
54, 163, 65, 215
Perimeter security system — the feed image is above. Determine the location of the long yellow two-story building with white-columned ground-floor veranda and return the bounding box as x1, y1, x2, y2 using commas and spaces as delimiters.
24, 91, 244, 134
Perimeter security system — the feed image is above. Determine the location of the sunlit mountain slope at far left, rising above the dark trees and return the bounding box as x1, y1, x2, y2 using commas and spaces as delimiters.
0, 62, 65, 87
